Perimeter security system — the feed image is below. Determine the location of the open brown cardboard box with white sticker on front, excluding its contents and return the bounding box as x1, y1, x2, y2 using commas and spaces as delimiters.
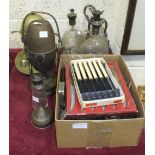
55, 55, 144, 148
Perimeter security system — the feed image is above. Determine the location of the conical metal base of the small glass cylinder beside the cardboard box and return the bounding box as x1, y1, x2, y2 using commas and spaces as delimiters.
31, 106, 54, 128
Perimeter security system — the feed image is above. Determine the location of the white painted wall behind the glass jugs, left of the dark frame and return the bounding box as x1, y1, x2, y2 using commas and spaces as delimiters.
9, 0, 129, 53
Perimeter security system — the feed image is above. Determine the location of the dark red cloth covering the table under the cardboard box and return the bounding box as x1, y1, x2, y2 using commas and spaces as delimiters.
9, 49, 145, 155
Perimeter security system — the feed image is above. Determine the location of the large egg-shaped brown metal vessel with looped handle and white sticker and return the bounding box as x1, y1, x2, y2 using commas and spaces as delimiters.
21, 11, 62, 94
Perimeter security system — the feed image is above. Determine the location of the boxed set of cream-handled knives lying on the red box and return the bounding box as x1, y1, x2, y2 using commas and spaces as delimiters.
70, 58, 125, 108
